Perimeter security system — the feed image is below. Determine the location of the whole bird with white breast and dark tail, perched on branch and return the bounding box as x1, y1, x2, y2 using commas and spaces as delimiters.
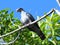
17, 8, 46, 40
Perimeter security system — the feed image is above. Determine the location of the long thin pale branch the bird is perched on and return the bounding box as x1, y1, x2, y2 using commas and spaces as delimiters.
0, 9, 55, 38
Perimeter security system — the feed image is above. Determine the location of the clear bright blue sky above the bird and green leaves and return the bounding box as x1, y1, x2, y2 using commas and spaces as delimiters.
0, 0, 60, 19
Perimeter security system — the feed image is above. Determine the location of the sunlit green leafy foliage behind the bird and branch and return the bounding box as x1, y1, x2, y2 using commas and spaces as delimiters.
0, 9, 60, 45
